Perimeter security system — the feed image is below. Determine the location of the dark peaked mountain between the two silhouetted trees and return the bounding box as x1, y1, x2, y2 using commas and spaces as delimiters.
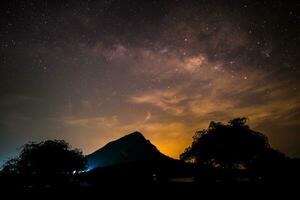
86, 132, 172, 170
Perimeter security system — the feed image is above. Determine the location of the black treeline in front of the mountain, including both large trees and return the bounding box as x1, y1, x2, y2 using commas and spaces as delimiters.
0, 118, 300, 189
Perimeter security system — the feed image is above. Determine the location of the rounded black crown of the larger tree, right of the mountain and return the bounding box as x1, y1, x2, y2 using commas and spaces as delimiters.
180, 117, 270, 169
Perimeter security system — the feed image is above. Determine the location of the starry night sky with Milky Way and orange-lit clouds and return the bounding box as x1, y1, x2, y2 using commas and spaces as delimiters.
0, 0, 300, 162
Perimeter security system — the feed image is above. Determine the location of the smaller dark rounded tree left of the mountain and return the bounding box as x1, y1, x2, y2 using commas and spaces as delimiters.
2, 140, 86, 184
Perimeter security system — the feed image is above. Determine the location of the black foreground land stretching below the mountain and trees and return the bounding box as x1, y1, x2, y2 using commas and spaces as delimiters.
0, 161, 300, 199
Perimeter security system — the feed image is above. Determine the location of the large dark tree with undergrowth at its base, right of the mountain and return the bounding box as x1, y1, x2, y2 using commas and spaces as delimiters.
180, 117, 297, 183
